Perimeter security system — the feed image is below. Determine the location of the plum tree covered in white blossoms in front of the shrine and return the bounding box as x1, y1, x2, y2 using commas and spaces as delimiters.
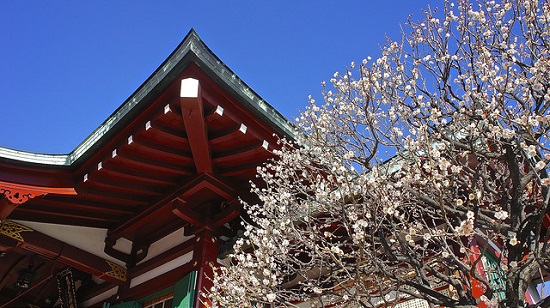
209, 0, 550, 307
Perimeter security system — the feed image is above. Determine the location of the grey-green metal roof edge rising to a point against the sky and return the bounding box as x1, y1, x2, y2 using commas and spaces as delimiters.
0, 29, 294, 166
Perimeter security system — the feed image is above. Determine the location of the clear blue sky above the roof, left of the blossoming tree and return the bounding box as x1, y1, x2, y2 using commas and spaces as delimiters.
0, 0, 442, 154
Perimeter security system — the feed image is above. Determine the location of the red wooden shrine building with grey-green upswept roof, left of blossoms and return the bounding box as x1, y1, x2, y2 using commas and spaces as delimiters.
0, 30, 293, 308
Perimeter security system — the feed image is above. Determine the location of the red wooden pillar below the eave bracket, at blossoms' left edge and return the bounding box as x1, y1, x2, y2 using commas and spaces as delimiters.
195, 229, 218, 308
